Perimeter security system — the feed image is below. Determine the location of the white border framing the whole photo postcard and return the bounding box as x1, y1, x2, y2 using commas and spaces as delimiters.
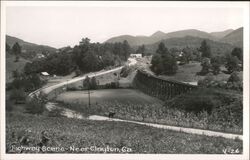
0, 1, 249, 160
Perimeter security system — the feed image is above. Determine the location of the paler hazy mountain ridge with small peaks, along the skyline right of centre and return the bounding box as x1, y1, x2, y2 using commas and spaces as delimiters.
106, 29, 221, 46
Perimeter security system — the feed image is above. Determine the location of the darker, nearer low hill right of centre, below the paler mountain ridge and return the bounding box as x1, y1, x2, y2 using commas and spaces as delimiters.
145, 36, 234, 54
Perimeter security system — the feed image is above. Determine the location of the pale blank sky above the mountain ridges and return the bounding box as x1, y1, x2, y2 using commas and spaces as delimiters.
6, 6, 243, 48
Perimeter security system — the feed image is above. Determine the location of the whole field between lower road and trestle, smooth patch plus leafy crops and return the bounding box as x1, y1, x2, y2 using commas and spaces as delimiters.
56, 89, 243, 134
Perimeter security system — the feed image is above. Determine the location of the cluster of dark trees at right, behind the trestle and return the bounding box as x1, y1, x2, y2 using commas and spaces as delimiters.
151, 40, 243, 75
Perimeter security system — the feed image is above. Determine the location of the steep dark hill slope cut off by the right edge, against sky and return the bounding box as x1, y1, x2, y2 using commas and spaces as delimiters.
220, 27, 243, 47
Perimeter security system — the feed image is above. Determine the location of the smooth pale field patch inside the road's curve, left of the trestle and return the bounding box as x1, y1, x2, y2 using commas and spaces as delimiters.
56, 89, 163, 105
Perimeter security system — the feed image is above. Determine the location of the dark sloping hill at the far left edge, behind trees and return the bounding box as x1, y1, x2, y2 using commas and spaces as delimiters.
6, 35, 57, 59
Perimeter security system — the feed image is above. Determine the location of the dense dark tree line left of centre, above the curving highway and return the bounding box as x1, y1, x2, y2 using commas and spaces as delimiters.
24, 38, 132, 75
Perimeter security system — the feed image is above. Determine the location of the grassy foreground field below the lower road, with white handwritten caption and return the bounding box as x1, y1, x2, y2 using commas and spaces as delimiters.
6, 113, 243, 154
